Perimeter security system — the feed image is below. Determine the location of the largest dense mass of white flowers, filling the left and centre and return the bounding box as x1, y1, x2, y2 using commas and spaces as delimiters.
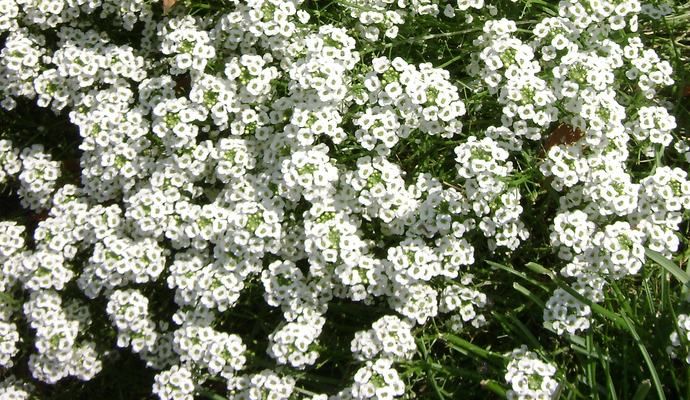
3, 21, 484, 396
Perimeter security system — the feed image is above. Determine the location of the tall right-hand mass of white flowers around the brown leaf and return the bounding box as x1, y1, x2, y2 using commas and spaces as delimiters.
456, 0, 688, 334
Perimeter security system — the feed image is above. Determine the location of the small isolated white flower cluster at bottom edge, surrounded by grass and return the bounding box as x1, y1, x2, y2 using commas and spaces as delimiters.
505, 346, 558, 400
